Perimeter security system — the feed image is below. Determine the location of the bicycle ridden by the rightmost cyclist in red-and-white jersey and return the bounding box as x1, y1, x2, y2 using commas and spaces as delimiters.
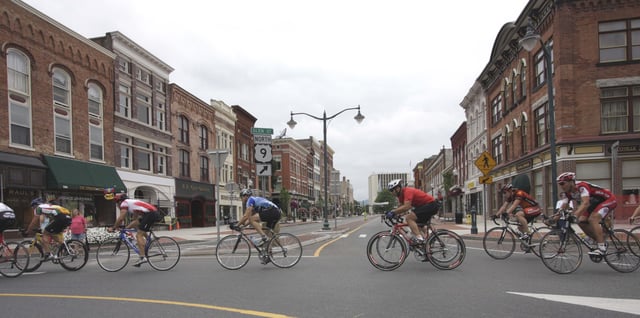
540, 209, 640, 274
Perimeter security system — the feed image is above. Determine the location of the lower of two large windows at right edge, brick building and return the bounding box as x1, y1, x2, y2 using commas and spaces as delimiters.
600, 86, 640, 134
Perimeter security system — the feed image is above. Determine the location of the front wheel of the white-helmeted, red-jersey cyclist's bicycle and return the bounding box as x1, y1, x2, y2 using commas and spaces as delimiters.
367, 231, 408, 271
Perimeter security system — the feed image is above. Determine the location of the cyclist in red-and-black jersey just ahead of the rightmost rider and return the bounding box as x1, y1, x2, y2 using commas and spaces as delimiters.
495, 183, 542, 241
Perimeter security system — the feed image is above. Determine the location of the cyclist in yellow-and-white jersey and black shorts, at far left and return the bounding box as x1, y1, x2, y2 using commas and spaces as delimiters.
27, 198, 71, 261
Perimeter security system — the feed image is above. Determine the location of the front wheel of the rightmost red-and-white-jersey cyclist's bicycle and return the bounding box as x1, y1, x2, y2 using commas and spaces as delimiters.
540, 229, 582, 274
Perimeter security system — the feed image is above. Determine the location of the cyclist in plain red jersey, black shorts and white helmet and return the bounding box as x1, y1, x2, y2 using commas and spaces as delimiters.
386, 179, 440, 244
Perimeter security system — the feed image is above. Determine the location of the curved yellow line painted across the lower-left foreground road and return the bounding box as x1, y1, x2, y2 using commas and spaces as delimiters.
0, 293, 290, 318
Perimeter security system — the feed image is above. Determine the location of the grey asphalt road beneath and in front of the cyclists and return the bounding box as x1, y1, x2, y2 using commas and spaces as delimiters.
0, 220, 640, 318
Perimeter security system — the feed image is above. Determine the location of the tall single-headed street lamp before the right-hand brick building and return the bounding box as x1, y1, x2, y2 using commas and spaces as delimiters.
520, 20, 558, 206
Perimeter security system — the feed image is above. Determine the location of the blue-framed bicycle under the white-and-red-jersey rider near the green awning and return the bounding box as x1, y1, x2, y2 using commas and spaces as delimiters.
96, 226, 181, 272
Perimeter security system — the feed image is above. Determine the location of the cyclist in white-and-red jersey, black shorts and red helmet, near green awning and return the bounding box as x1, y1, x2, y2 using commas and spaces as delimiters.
110, 193, 160, 267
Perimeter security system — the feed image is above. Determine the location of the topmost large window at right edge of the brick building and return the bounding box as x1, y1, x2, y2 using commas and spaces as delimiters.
598, 19, 640, 63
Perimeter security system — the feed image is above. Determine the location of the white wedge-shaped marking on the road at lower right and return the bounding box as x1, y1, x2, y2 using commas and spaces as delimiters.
507, 292, 640, 315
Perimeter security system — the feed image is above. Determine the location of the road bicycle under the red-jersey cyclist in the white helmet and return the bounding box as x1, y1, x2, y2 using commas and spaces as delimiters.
367, 216, 466, 271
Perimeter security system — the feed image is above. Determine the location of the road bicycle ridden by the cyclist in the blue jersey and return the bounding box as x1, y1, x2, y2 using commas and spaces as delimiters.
216, 222, 302, 270
